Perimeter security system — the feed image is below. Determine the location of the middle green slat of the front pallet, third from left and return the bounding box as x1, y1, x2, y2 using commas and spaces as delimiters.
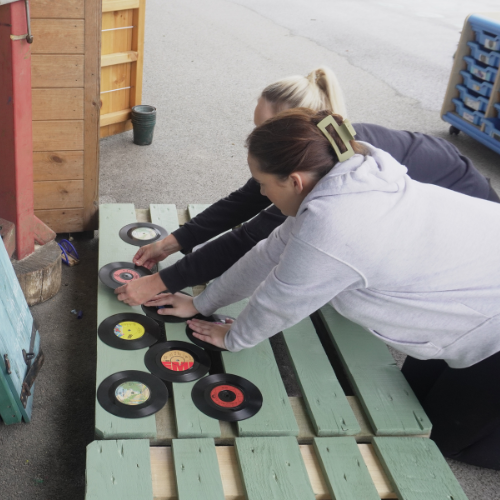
235, 436, 315, 500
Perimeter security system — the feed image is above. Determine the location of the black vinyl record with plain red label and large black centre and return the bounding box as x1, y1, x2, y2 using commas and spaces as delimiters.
191, 373, 262, 422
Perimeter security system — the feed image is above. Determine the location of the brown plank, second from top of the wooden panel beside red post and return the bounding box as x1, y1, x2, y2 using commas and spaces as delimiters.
31, 19, 84, 54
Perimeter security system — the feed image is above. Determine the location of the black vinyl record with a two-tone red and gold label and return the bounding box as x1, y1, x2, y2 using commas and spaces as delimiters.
144, 341, 210, 382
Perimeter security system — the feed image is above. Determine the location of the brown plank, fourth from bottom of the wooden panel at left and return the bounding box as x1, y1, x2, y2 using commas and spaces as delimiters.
33, 120, 84, 151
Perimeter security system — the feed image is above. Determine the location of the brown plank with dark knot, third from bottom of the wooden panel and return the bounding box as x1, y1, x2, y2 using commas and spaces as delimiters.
33, 151, 83, 181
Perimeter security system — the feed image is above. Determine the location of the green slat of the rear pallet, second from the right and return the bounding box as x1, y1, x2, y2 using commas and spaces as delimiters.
283, 318, 361, 436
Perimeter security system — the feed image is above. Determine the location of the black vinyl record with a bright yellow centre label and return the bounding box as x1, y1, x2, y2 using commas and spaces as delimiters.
97, 313, 162, 351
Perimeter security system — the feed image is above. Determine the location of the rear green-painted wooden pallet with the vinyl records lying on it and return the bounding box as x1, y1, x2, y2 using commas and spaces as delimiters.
96, 204, 431, 444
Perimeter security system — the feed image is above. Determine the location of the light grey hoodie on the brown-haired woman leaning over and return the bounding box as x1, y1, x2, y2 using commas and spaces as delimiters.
194, 144, 500, 368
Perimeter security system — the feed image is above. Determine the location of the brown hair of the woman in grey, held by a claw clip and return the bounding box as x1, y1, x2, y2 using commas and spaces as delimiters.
246, 108, 369, 179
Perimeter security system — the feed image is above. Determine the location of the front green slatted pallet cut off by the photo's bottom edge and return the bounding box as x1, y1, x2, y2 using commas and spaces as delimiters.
86, 436, 467, 500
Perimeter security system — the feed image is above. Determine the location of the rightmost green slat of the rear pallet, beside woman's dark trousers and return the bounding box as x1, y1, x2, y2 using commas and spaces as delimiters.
320, 305, 432, 435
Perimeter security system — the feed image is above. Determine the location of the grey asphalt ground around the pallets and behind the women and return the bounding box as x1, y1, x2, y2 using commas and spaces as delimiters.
0, 0, 500, 500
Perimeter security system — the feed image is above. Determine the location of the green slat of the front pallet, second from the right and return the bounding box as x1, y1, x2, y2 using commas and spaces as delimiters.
314, 437, 380, 500
